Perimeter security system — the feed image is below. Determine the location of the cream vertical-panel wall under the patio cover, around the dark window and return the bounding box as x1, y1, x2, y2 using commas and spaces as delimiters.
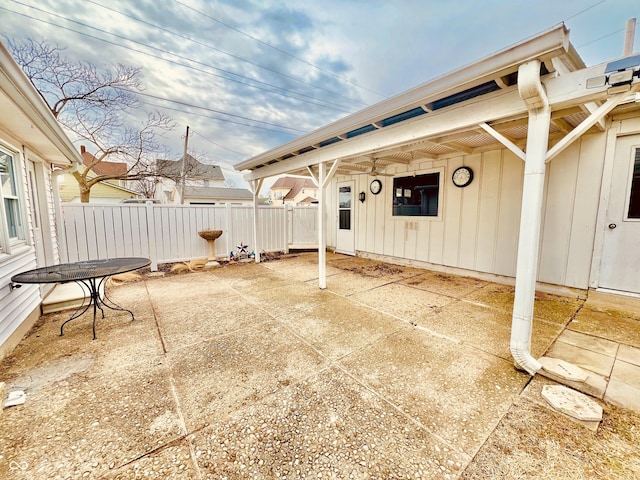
327, 133, 606, 288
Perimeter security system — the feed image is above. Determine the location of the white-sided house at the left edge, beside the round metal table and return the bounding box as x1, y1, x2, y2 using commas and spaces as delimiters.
0, 41, 82, 358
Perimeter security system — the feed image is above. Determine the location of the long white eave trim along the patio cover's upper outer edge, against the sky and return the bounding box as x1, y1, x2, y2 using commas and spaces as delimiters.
235, 24, 571, 171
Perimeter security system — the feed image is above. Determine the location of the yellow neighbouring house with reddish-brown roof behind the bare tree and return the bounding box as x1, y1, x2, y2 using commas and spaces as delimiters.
58, 145, 142, 204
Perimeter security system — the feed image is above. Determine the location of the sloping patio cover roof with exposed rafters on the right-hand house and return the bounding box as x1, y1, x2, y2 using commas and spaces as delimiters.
235, 24, 589, 179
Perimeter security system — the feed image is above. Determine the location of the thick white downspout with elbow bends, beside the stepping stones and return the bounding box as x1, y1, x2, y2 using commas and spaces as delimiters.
510, 60, 551, 375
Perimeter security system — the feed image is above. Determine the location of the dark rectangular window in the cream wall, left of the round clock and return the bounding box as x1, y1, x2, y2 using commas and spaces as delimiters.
392, 172, 440, 217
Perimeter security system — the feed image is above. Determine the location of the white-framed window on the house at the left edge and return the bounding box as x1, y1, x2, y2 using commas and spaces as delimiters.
0, 148, 25, 253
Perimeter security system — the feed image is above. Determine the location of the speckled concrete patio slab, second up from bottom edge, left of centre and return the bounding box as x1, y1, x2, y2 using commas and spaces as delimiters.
168, 321, 328, 431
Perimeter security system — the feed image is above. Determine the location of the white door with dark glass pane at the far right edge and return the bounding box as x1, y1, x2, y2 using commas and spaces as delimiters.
598, 135, 640, 294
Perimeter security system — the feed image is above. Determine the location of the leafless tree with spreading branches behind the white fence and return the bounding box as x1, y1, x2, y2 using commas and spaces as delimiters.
8, 39, 174, 202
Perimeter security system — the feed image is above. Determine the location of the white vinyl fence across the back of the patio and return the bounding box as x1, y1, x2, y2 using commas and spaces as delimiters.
61, 203, 318, 269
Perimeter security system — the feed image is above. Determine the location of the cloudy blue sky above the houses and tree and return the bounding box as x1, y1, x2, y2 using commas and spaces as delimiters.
0, 0, 640, 194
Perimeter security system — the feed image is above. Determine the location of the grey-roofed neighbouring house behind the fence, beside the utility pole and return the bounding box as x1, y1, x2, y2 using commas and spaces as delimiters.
156, 154, 225, 203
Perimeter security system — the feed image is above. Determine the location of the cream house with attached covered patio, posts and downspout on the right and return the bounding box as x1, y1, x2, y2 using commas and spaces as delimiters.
236, 25, 640, 373
